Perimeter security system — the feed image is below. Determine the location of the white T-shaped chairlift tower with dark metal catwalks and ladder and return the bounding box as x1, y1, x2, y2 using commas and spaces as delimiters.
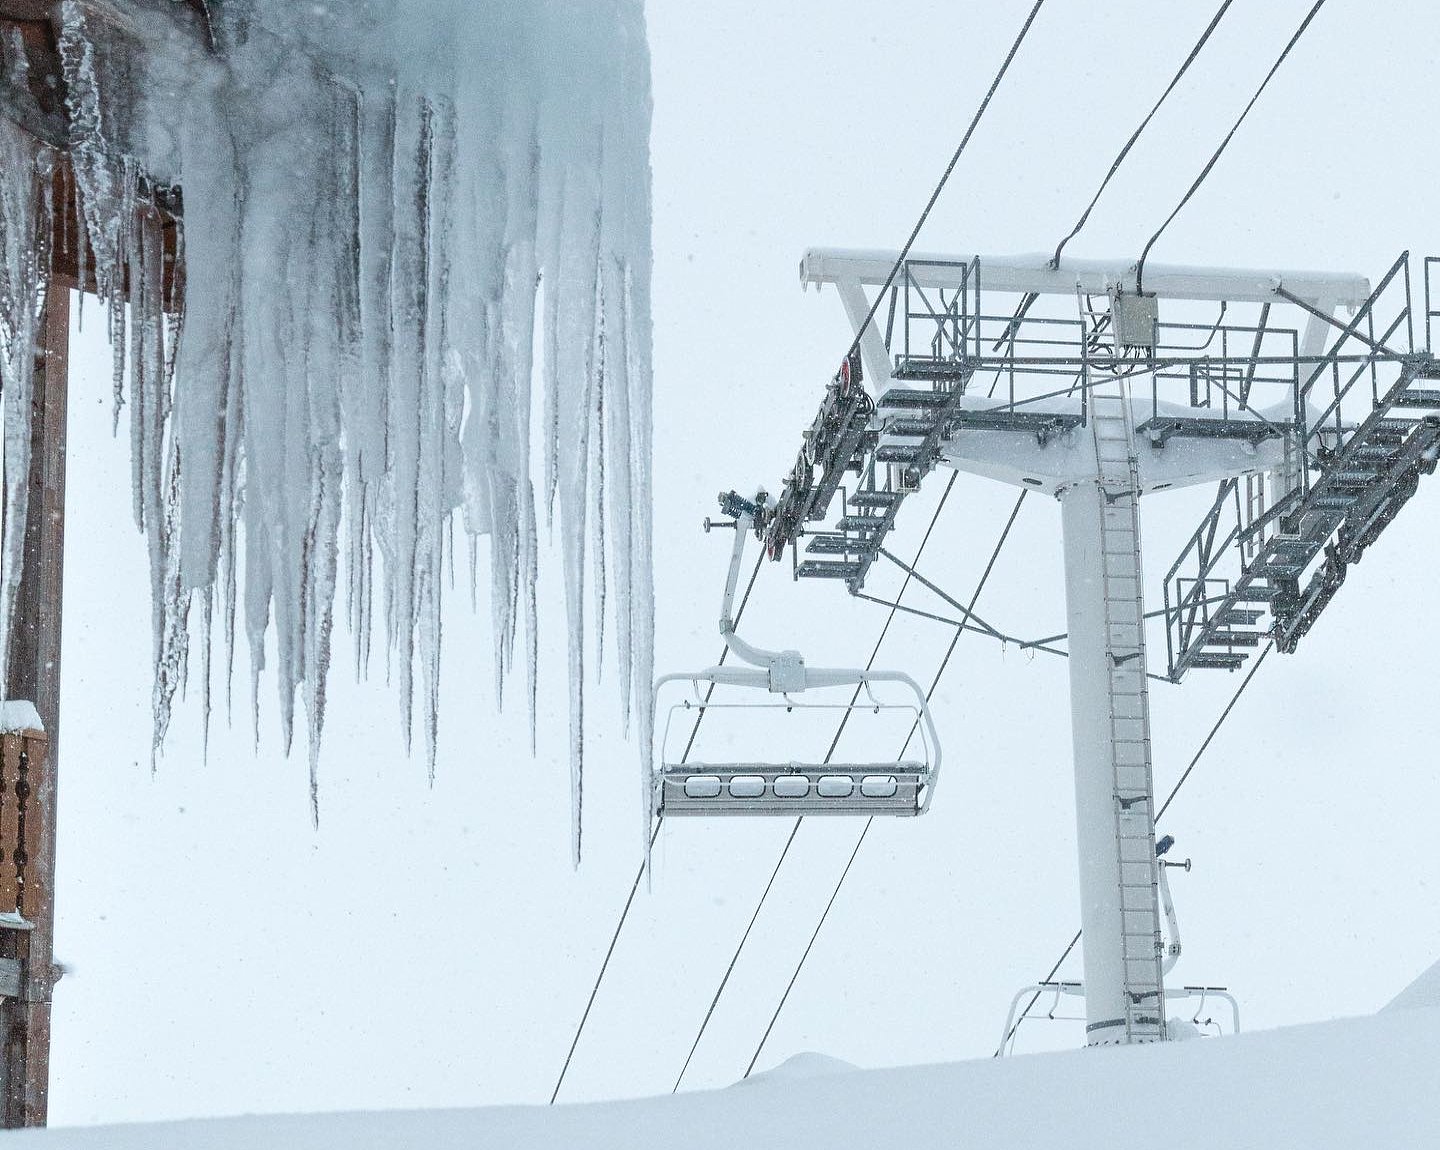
762, 249, 1440, 1045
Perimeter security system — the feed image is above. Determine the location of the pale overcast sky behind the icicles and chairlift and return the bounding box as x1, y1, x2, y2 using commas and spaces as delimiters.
39, 0, 1440, 1123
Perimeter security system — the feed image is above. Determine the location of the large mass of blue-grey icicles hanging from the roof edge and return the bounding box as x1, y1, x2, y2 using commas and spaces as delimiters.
0, 0, 652, 859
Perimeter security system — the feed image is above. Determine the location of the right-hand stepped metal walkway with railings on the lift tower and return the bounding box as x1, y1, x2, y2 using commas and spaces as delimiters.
1164, 253, 1440, 679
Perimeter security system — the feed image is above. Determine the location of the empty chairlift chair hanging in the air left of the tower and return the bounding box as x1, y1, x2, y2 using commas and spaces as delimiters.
647, 492, 940, 818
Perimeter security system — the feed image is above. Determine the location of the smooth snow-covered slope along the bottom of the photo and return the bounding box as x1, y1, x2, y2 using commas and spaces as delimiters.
14, 1009, 1440, 1150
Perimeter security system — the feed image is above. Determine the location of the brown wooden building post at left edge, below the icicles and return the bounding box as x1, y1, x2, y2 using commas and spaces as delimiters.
0, 281, 71, 1128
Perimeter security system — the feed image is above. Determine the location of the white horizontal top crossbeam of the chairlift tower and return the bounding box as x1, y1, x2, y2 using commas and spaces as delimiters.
801, 248, 1371, 308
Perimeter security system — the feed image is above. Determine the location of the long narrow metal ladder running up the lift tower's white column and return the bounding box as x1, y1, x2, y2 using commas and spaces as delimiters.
1090, 380, 1165, 1042
